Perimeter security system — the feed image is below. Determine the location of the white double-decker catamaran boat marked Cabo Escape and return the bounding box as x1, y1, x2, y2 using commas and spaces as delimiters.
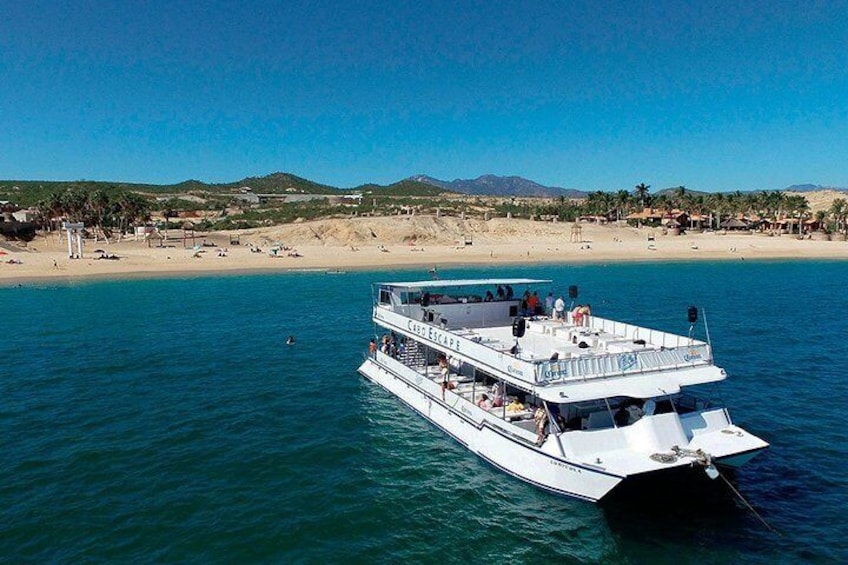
359, 278, 768, 501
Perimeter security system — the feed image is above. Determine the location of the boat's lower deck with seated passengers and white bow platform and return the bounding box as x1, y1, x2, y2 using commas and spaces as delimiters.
362, 346, 767, 482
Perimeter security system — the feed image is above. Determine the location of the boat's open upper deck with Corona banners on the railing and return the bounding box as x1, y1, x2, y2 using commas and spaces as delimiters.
374, 279, 724, 397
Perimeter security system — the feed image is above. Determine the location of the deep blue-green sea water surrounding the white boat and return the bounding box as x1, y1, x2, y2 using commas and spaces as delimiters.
0, 261, 848, 565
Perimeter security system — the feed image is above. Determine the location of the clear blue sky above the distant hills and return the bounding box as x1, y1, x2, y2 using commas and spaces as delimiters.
0, 0, 848, 191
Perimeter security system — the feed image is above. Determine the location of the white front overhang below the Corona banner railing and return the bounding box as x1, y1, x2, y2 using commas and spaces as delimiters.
536, 365, 727, 402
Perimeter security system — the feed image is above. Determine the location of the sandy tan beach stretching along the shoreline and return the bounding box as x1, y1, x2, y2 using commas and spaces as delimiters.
0, 216, 848, 284
